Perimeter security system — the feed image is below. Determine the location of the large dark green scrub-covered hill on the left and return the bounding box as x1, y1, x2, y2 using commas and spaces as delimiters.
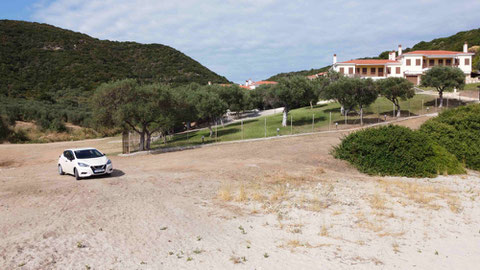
0, 20, 228, 98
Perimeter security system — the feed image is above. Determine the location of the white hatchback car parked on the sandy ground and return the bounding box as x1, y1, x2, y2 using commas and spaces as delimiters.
58, 148, 113, 180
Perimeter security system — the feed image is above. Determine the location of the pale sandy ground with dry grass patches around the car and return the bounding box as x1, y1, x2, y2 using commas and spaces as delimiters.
0, 116, 480, 269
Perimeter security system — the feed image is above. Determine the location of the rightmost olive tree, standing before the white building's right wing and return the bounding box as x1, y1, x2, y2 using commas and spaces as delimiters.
422, 66, 465, 107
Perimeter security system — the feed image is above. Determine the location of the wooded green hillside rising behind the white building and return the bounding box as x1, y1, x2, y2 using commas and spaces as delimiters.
267, 28, 480, 81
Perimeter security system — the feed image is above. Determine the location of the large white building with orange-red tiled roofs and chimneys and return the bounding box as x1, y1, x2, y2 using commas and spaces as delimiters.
333, 42, 474, 85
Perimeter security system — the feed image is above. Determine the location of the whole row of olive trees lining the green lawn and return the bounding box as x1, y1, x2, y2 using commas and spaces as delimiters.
93, 67, 464, 150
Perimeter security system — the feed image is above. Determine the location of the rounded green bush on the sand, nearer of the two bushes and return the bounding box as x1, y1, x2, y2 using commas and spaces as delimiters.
333, 125, 465, 177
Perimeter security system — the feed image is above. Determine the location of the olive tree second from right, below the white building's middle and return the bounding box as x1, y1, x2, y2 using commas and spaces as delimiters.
377, 77, 415, 117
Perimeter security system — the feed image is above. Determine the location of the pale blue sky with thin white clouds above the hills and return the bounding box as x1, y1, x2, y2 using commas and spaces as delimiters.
0, 0, 480, 83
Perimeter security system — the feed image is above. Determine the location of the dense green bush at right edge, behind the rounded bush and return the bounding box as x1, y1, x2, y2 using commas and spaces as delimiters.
420, 104, 480, 170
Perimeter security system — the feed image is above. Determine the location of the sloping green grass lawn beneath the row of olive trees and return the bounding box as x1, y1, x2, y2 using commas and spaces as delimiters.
152, 95, 435, 148
